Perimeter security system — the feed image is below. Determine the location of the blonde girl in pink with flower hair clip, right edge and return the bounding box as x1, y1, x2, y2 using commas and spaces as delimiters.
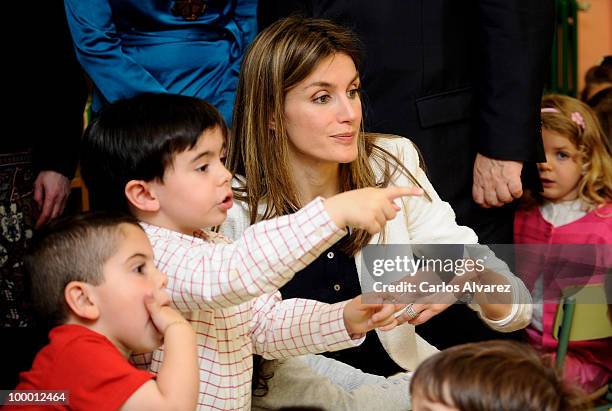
514, 95, 612, 391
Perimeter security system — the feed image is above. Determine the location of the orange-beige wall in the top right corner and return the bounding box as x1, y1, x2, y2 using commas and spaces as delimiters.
580, 0, 612, 93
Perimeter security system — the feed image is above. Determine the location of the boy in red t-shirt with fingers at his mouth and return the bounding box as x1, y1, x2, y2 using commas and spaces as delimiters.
7, 214, 199, 410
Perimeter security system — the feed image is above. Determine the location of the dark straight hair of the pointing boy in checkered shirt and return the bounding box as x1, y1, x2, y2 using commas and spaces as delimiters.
81, 93, 227, 211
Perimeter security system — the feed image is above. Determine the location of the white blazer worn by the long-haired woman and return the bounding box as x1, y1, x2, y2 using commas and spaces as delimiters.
220, 136, 532, 370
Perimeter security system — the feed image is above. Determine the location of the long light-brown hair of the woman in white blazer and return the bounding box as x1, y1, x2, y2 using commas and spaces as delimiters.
227, 17, 429, 255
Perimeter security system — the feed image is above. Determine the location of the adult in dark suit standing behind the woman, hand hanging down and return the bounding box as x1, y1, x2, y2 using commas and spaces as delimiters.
259, 0, 554, 348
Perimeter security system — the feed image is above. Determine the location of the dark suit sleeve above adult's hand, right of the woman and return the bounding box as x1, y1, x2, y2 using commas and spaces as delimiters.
475, 0, 554, 161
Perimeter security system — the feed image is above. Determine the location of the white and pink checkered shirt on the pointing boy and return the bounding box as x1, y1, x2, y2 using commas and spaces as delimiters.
133, 198, 362, 410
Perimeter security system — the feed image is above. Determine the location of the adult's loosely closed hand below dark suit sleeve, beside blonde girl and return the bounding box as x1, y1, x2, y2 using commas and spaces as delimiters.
472, 153, 523, 208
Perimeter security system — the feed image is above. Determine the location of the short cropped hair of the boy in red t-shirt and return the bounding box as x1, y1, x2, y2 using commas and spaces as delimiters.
25, 212, 141, 326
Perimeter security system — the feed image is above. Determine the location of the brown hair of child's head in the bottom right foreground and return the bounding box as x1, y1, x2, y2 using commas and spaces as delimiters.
410, 341, 587, 411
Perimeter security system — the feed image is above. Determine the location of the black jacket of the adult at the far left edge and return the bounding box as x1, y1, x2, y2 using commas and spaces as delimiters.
0, 0, 87, 178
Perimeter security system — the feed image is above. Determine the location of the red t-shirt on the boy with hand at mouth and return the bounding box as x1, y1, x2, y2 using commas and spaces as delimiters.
5, 324, 154, 411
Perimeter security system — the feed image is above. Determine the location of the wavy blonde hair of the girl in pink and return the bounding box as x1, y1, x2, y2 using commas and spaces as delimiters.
542, 94, 612, 207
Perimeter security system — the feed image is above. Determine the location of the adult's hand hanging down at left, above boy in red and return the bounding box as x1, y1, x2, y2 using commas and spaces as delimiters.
34, 171, 70, 228
